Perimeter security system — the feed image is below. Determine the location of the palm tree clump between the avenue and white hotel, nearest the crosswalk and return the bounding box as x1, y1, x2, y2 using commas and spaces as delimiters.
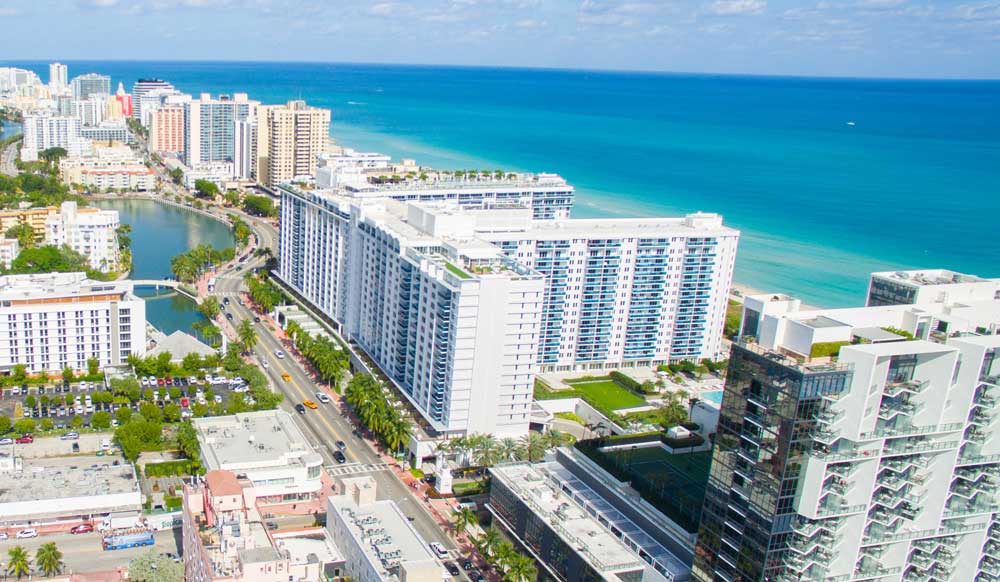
344, 374, 413, 454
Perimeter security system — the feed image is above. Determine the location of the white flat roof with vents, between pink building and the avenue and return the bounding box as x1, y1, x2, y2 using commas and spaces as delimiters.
328, 495, 437, 574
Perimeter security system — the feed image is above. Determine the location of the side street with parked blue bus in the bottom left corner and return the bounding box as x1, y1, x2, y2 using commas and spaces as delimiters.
0, 528, 181, 573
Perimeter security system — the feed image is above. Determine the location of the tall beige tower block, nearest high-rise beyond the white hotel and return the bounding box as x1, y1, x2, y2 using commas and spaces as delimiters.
256, 101, 330, 187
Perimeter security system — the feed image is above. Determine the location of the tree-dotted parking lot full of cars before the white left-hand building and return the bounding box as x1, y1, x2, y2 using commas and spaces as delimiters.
0, 374, 254, 430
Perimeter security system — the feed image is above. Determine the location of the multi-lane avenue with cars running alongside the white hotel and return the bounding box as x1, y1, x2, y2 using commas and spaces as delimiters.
214, 215, 466, 560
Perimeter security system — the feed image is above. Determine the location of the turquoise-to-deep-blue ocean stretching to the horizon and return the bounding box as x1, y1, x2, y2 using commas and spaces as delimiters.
3, 61, 1000, 307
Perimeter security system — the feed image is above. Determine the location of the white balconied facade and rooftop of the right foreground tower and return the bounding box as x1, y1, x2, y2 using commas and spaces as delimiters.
702, 280, 1000, 580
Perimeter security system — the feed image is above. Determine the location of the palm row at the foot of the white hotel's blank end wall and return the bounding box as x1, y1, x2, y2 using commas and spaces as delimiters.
438, 430, 573, 467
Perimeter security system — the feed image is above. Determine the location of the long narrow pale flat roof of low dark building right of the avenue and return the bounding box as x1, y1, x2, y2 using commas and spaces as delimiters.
491, 463, 646, 574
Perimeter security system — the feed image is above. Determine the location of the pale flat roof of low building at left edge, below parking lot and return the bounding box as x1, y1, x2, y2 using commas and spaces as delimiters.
0, 452, 142, 513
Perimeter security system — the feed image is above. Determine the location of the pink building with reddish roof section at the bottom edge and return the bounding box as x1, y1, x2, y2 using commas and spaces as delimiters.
181, 469, 343, 582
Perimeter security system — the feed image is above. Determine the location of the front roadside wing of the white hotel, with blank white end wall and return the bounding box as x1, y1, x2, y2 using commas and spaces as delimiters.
278, 189, 544, 436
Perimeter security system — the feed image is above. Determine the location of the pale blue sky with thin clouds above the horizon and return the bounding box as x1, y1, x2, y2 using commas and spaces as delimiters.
0, 0, 1000, 78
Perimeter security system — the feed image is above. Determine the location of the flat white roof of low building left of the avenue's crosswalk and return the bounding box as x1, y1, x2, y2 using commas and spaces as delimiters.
193, 410, 317, 473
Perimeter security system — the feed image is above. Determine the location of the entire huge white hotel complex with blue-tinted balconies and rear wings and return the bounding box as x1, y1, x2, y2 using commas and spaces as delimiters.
279, 174, 739, 435
